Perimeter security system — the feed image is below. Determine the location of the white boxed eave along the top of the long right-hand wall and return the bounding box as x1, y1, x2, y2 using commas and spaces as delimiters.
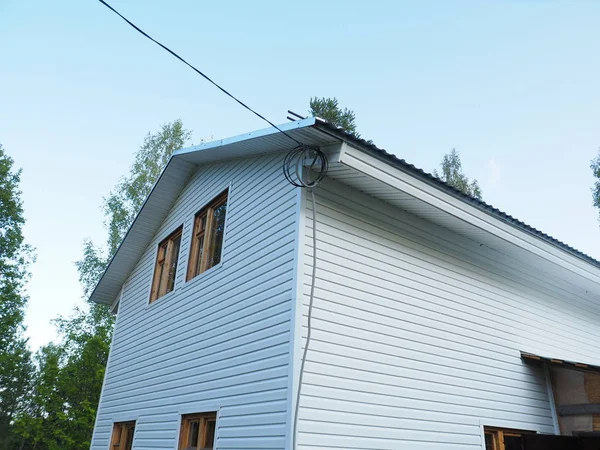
330, 143, 600, 301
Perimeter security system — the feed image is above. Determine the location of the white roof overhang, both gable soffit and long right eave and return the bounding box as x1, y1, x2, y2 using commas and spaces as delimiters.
90, 118, 600, 304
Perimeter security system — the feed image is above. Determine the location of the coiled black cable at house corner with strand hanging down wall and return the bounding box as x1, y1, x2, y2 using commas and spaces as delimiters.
283, 145, 329, 450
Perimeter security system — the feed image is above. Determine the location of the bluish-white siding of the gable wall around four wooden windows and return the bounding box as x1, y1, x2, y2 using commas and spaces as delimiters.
91, 154, 298, 450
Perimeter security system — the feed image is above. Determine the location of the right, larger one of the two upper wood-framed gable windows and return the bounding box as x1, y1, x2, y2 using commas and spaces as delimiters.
187, 191, 227, 280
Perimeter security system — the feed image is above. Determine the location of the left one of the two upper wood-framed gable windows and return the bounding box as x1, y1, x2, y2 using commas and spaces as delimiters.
150, 227, 183, 303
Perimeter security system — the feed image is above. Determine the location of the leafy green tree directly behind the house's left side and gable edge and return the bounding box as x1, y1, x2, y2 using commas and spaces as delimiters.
13, 120, 191, 450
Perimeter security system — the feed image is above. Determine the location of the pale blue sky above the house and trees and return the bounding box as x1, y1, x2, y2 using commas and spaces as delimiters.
0, 0, 600, 350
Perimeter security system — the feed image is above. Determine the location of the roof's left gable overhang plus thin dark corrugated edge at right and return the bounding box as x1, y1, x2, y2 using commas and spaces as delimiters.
90, 117, 600, 304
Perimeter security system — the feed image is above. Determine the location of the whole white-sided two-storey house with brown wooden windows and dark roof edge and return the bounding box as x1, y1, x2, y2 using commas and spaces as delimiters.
91, 118, 600, 450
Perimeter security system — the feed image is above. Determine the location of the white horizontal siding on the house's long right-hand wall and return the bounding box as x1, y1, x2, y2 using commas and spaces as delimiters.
298, 181, 600, 450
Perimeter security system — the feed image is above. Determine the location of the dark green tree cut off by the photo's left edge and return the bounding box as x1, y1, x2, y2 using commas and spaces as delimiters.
0, 145, 33, 449
